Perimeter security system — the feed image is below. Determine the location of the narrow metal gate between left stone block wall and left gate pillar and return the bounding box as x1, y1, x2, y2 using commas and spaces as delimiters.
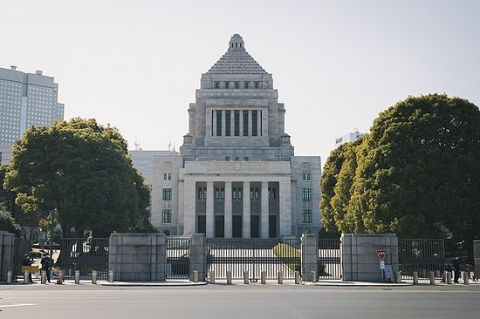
165, 236, 191, 279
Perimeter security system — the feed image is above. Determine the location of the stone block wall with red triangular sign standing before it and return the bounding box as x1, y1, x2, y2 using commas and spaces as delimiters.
340, 234, 398, 282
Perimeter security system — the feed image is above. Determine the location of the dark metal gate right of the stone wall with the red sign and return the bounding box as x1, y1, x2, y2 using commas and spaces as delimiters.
398, 239, 445, 279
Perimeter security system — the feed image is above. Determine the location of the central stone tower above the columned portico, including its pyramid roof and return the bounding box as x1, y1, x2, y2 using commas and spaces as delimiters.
180, 34, 293, 161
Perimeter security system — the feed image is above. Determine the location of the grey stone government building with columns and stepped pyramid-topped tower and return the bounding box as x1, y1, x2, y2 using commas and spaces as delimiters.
131, 34, 321, 238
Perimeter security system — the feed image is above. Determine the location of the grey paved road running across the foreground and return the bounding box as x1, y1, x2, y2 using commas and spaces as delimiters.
0, 285, 480, 319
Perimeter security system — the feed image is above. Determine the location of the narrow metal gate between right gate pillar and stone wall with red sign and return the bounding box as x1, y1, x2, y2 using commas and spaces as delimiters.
318, 238, 342, 279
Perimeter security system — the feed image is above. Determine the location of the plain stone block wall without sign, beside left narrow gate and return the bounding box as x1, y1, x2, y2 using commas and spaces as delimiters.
108, 234, 166, 281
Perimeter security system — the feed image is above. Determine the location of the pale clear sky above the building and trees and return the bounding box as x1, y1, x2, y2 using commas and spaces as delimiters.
0, 0, 480, 161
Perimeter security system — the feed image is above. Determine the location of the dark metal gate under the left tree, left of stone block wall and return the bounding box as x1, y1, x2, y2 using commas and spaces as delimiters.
58, 238, 109, 279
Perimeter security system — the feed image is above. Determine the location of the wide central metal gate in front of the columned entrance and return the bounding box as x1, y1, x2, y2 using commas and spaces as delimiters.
207, 238, 300, 281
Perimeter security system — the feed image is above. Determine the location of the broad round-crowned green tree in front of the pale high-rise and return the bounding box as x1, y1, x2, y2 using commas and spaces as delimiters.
5, 118, 150, 237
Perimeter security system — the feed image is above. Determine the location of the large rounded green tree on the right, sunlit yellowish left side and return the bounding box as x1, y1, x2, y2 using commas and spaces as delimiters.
321, 94, 480, 244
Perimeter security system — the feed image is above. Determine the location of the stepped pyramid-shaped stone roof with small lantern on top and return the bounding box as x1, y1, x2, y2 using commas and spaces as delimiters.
207, 34, 267, 74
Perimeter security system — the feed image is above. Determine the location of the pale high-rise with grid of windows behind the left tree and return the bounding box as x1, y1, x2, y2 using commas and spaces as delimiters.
0, 66, 64, 162
